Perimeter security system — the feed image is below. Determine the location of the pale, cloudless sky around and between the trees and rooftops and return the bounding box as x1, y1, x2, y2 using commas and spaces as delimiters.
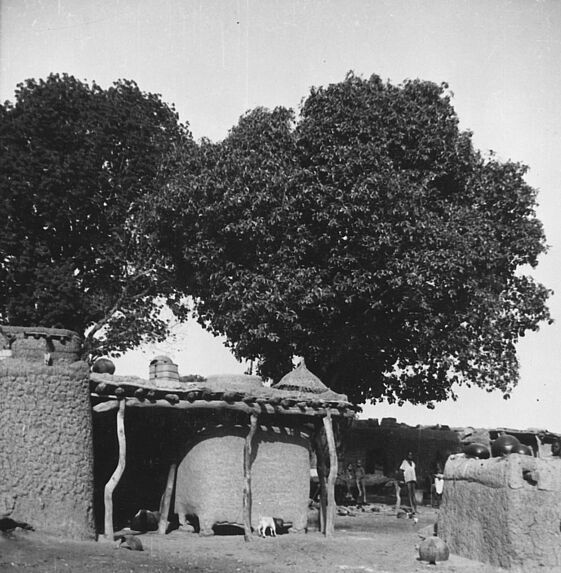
0, 0, 561, 432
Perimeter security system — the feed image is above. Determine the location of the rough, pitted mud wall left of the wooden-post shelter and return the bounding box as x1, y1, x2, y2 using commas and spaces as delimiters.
0, 358, 95, 539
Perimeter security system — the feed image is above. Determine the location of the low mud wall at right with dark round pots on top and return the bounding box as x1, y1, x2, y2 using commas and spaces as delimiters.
438, 454, 561, 571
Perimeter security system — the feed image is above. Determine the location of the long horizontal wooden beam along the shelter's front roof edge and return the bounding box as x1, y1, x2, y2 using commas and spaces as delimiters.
92, 393, 354, 418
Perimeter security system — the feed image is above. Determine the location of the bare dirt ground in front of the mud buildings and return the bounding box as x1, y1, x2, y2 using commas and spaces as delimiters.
0, 505, 504, 573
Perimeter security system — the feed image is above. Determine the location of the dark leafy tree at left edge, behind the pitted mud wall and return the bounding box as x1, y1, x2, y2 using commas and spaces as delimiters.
0, 71, 193, 356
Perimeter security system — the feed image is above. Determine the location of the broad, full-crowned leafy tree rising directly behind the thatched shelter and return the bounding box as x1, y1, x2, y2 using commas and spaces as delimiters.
149, 74, 550, 405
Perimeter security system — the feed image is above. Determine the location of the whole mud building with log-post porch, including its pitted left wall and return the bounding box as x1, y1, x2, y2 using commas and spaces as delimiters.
0, 327, 355, 539
